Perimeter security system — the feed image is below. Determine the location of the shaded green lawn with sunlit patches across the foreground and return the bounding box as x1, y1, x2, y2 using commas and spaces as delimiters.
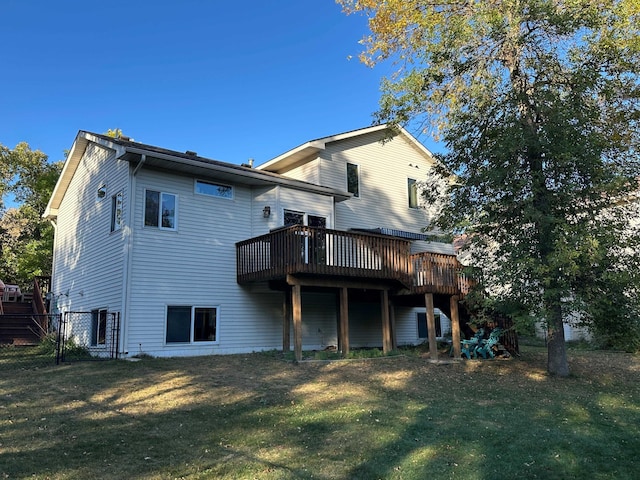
0, 347, 640, 480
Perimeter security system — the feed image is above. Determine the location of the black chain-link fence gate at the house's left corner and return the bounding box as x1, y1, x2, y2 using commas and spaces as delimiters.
56, 309, 120, 364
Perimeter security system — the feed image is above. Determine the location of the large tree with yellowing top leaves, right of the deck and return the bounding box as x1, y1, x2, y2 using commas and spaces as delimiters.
338, 0, 640, 376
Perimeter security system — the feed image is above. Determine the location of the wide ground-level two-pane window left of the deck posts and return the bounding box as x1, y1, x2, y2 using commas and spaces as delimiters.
167, 305, 218, 343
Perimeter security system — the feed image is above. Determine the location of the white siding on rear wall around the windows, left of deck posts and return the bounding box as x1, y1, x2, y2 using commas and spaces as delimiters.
127, 172, 335, 356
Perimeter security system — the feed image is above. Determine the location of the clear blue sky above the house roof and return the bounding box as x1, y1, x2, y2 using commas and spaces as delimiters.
0, 0, 440, 168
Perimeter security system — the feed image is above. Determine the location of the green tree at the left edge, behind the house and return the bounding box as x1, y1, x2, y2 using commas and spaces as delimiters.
0, 142, 62, 288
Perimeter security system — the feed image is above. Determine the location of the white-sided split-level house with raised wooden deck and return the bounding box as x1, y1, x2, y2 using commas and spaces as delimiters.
45, 126, 466, 358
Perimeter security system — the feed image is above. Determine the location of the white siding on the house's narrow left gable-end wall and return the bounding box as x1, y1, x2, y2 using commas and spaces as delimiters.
52, 144, 129, 311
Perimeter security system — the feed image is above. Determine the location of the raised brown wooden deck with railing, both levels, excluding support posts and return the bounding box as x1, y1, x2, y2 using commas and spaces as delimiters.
236, 226, 471, 296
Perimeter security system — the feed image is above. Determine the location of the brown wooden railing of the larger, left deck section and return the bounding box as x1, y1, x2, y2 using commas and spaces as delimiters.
236, 225, 411, 286
